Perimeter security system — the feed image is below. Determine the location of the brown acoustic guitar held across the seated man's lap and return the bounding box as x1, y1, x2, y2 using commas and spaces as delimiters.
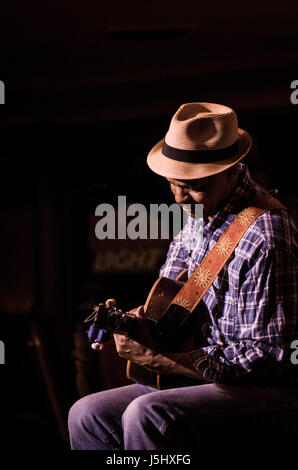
85, 270, 205, 389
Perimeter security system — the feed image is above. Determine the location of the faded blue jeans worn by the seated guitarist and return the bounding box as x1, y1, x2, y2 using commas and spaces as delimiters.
68, 384, 298, 450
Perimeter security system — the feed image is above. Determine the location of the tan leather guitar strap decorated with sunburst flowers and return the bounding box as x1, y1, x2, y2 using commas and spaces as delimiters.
169, 194, 285, 313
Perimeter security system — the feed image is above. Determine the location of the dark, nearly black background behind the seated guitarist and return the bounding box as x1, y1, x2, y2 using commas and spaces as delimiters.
0, 0, 298, 452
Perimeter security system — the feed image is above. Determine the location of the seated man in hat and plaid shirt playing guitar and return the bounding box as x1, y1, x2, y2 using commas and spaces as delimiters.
69, 103, 298, 450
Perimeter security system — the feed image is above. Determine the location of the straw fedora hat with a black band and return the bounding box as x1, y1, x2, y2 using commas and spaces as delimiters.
147, 103, 251, 179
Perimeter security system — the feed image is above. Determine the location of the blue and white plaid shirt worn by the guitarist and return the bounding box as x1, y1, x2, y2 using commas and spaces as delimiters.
160, 163, 298, 383
